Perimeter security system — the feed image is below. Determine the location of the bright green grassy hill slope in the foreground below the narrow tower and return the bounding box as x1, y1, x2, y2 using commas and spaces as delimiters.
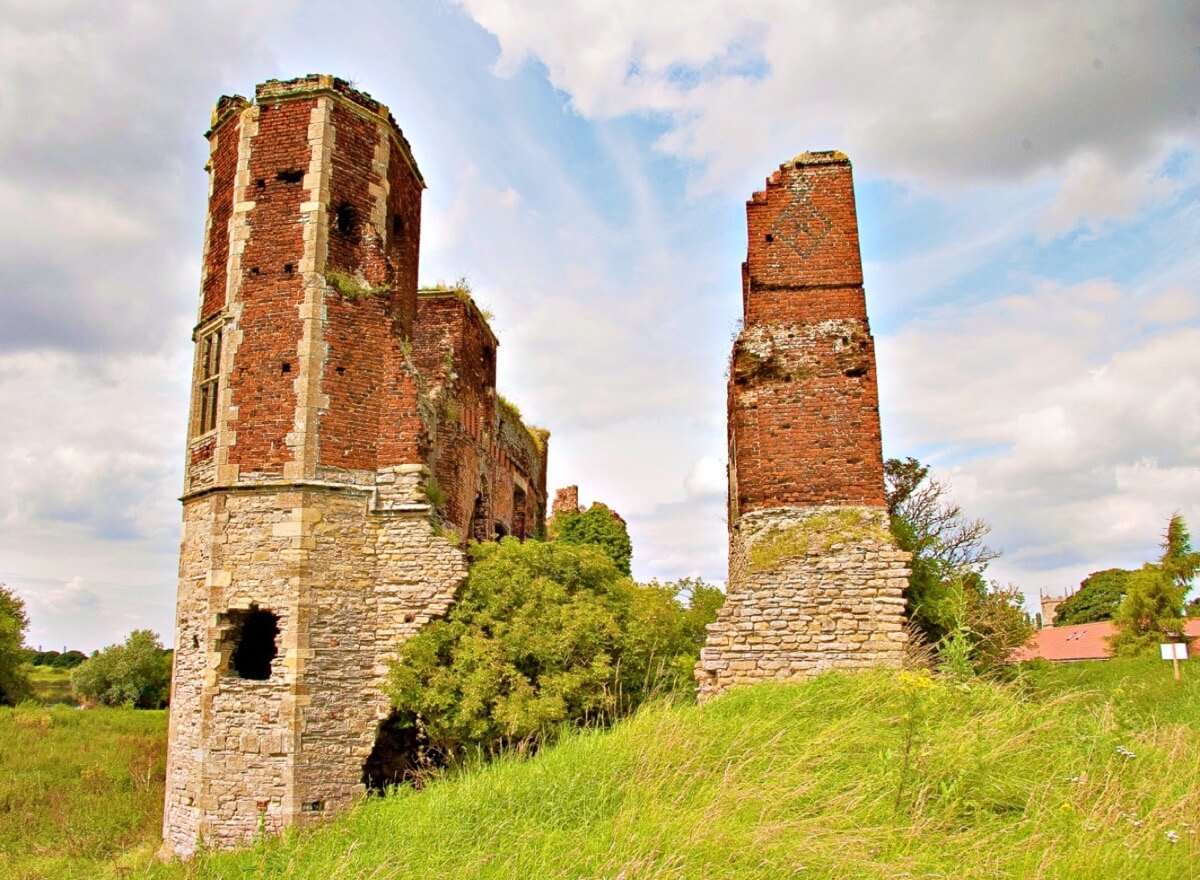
152, 660, 1200, 880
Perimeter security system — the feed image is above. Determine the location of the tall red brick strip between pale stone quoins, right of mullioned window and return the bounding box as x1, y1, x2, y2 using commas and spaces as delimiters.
229, 98, 316, 473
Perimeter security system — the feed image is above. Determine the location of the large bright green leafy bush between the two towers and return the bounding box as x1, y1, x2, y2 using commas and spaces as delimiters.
389, 538, 713, 768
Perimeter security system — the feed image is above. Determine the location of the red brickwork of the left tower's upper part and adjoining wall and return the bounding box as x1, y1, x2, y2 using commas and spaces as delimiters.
190, 77, 546, 521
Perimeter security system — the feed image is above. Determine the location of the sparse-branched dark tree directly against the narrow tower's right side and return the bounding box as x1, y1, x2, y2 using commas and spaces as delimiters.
883, 457, 1000, 645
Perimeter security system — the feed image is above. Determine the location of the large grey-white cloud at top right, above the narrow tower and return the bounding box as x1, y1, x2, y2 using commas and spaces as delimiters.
458, 0, 1200, 194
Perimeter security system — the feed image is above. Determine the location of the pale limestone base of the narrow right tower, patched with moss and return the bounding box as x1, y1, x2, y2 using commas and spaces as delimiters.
696, 507, 910, 700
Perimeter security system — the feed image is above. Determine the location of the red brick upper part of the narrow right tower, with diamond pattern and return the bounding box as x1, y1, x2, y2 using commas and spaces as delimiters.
728, 161, 883, 516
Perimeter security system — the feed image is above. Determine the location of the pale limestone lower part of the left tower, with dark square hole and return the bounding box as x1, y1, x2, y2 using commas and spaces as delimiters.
163, 483, 467, 857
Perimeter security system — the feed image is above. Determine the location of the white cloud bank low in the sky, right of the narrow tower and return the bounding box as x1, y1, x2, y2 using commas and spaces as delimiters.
878, 282, 1200, 593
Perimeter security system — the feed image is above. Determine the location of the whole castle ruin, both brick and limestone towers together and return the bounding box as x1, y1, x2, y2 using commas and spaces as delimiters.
163, 76, 907, 857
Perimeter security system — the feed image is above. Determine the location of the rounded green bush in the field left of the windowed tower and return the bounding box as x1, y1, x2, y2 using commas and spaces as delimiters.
71, 629, 172, 708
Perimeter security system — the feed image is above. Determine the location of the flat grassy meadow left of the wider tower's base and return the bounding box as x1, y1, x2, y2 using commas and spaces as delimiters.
0, 702, 167, 880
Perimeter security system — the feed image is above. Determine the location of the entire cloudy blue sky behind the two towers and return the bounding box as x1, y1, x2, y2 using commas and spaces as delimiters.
0, 0, 1200, 651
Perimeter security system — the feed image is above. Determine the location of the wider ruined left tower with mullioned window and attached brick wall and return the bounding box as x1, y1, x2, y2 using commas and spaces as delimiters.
163, 76, 547, 856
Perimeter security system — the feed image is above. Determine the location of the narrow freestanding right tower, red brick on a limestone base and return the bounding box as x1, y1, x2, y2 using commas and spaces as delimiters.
696, 152, 908, 698
